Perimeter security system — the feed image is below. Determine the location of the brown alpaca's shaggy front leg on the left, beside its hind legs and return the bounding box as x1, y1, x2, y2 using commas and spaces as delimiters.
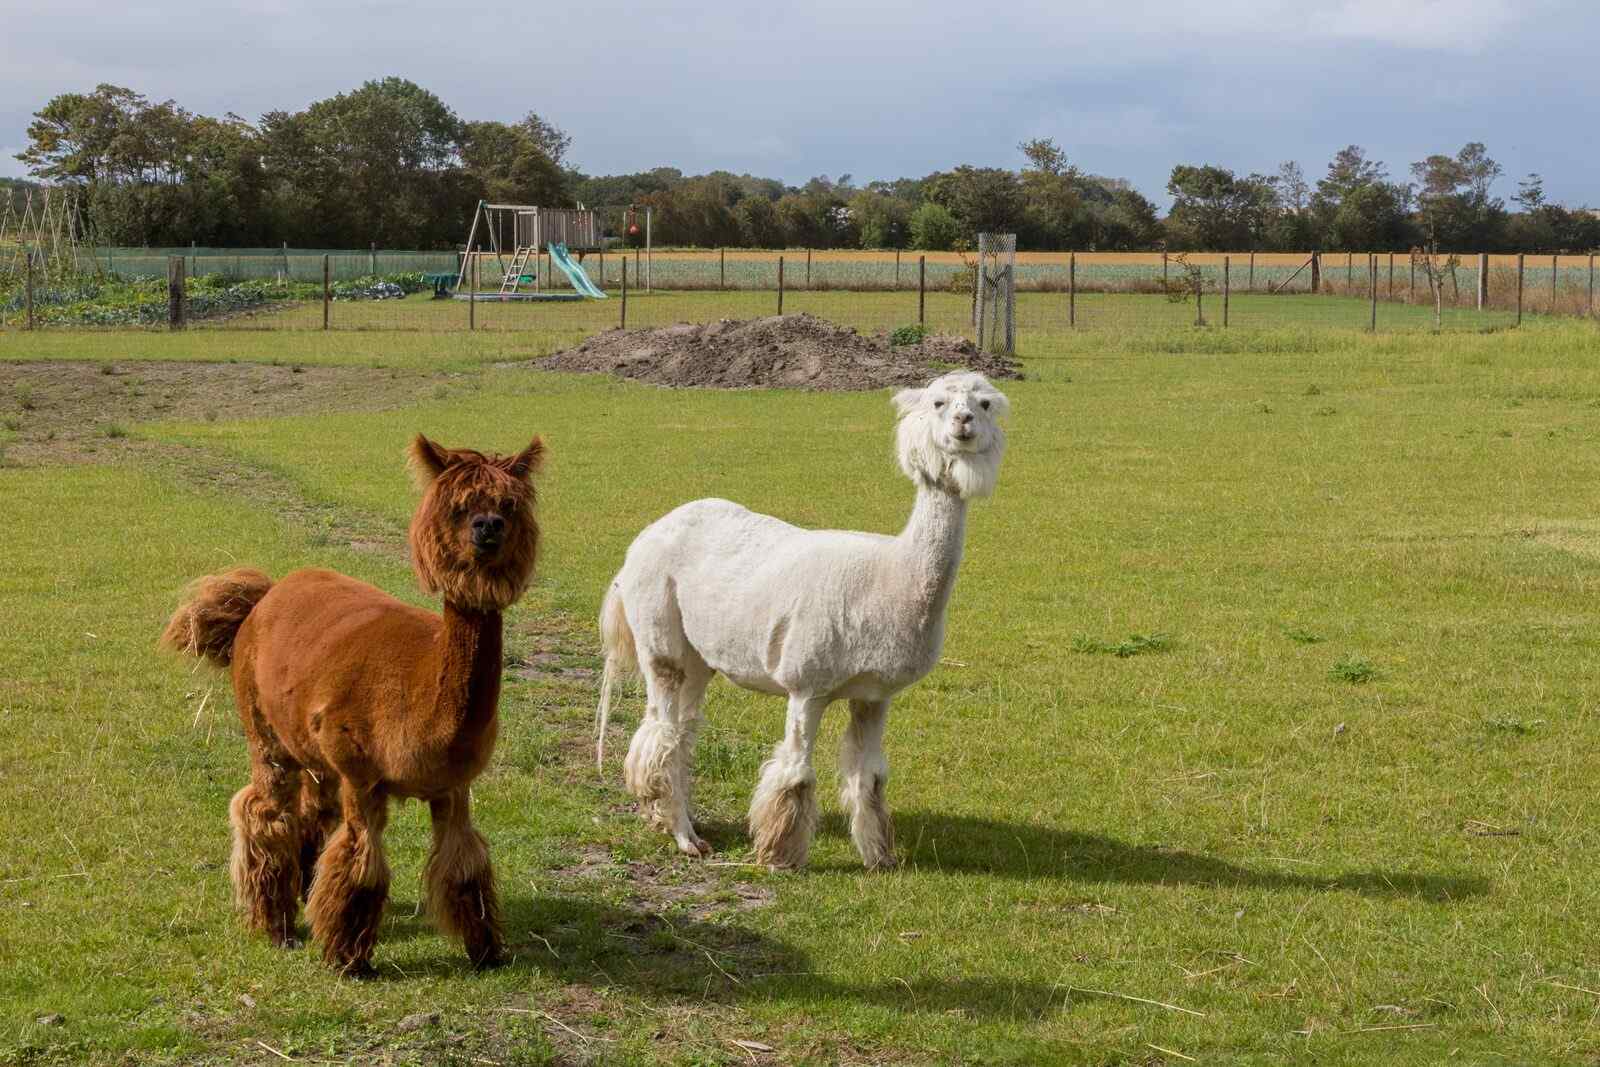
306, 782, 389, 977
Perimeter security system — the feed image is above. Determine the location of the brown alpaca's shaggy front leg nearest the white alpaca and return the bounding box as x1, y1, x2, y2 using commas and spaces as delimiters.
422, 789, 504, 966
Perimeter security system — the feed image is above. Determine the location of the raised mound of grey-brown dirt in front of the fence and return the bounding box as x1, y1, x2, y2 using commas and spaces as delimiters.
538, 314, 1022, 390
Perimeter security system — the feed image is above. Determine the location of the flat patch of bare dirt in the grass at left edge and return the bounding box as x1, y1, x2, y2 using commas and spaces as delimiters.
0, 360, 434, 466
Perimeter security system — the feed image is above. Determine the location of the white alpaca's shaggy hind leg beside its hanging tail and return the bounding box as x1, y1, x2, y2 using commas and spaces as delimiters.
622, 657, 710, 856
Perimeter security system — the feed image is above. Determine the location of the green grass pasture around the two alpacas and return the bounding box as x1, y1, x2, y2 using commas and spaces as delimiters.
0, 303, 1600, 1064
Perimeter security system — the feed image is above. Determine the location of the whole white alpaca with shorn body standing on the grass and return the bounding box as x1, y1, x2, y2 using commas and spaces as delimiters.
597, 373, 1008, 869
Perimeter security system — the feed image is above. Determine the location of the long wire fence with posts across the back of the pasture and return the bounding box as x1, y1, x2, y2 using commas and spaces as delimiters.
0, 250, 1595, 342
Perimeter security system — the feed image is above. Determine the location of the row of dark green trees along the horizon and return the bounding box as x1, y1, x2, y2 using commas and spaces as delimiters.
10, 77, 1600, 253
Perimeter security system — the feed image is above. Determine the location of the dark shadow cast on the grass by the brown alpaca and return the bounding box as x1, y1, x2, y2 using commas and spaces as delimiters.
374, 893, 1064, 1019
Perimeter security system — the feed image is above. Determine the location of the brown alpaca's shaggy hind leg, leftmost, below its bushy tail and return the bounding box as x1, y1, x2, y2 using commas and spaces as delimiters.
227, 744, 301, 945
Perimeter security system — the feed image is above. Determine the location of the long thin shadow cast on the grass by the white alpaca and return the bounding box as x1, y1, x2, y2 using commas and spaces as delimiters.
870, 811, 1490, 902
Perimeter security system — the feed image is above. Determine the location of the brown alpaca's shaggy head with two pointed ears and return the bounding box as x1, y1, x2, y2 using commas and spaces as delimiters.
410, 434, 544, 611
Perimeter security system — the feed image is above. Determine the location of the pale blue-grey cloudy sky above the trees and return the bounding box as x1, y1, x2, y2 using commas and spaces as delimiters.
0, 0, 1600, 205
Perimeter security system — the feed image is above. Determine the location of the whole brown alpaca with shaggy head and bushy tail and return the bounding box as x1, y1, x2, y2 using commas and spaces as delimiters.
162, 435, 544, 974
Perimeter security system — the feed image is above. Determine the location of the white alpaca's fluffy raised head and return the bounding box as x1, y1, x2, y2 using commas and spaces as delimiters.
894, 371, 1011, 499
